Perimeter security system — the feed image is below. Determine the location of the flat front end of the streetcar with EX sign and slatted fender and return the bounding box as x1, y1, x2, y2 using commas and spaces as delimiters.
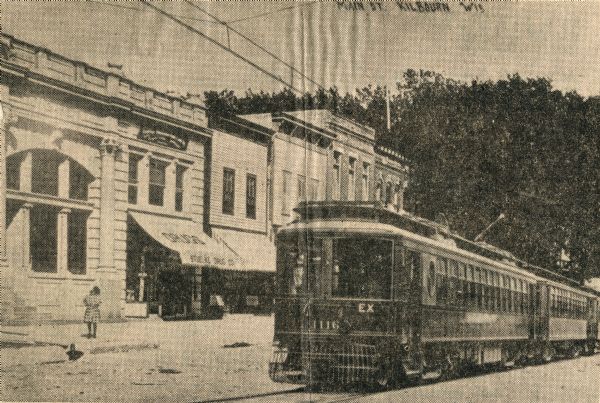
269, 226, 400, 385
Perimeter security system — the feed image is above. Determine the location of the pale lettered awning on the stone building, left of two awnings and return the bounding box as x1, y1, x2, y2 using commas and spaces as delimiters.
129, 211, 243, 270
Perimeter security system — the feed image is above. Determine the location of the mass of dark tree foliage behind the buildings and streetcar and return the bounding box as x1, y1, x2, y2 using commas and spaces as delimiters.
205, 70, 600, 280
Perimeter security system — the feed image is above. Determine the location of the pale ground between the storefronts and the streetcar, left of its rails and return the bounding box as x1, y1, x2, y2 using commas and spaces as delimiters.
1, 315, 295, 402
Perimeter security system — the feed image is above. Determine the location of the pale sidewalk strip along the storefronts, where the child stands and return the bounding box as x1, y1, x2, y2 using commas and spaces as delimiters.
0, 315, 273, 363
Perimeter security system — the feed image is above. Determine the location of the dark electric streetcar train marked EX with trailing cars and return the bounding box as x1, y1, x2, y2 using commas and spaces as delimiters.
269, 202, 600, 384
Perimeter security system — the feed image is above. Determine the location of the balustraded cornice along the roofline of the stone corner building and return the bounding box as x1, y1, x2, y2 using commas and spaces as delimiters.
0, 34, 211, 137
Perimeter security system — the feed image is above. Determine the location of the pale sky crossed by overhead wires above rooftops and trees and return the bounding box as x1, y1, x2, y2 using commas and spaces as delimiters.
0, 0, 600, 96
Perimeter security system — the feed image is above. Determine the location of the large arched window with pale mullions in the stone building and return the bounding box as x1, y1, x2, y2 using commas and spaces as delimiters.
6, 150, 94, 274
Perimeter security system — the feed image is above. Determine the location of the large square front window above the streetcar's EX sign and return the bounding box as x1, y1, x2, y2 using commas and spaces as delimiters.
332, 238, 393, 299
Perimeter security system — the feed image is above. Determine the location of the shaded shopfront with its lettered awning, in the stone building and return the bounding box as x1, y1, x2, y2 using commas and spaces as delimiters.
127, 212, 242, 319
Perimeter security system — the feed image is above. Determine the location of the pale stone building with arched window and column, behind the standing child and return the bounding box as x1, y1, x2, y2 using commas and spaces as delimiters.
0, 35, 221, 323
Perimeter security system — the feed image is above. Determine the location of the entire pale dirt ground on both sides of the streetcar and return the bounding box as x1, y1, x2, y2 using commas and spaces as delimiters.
1, 315, 600, 403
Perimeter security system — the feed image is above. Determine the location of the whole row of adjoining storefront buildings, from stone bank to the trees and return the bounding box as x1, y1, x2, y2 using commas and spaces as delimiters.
0, 34, 408, 324
